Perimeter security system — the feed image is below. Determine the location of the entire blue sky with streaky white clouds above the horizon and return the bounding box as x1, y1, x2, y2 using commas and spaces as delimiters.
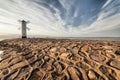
0, 0, 120, 37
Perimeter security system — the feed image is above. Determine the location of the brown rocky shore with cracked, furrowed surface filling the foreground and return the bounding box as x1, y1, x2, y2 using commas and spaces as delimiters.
0, 39, 120, 80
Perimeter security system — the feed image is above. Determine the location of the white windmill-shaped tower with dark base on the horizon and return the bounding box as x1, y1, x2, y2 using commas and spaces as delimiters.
18, 20, 30, 38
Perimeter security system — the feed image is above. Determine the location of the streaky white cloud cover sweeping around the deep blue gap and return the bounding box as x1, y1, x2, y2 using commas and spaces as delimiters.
0, 0, 120, 36
